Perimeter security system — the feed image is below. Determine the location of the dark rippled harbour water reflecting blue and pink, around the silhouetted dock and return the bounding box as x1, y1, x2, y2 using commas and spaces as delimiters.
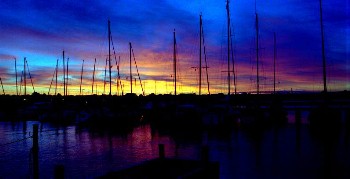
0, 113, 350, 178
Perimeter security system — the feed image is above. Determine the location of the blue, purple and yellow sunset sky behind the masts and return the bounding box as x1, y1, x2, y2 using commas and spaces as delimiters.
0, 0, 350, 95
